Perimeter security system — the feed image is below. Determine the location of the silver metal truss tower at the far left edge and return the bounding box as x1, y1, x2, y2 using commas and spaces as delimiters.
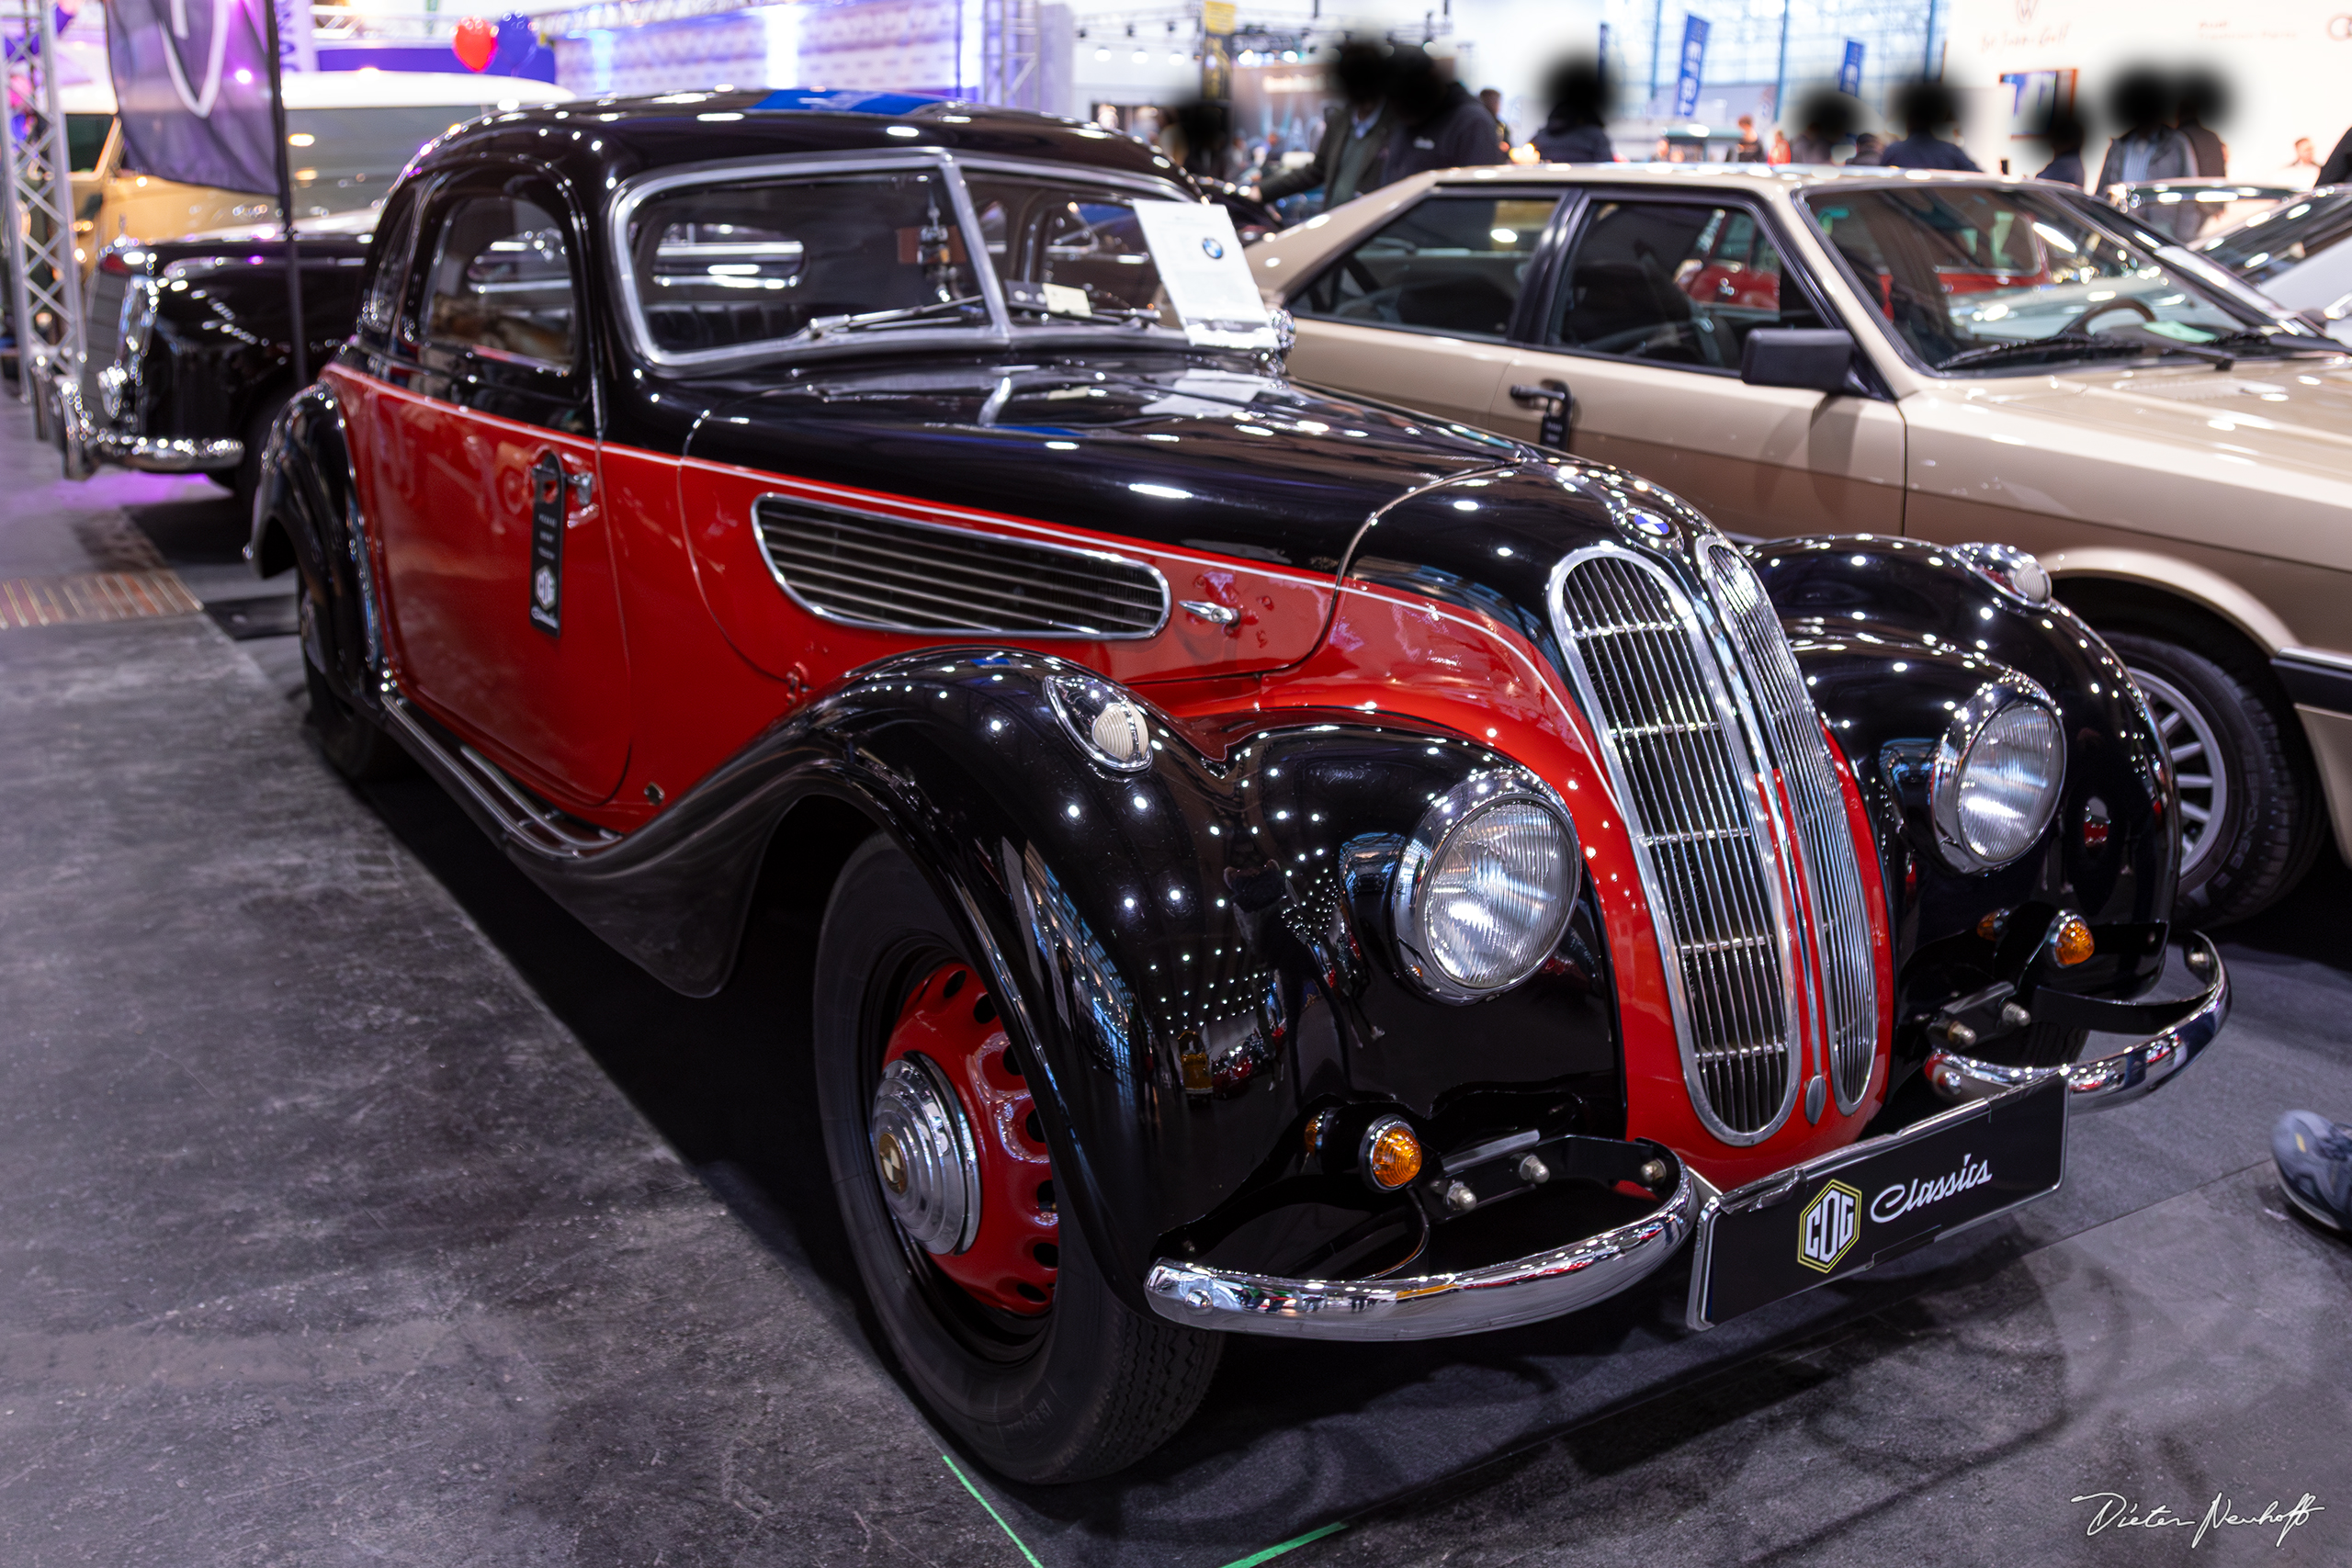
0, 0, 83, 402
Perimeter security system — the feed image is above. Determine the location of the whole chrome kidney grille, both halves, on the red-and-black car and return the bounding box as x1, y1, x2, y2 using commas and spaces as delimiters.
1553, 541, 1877, 1145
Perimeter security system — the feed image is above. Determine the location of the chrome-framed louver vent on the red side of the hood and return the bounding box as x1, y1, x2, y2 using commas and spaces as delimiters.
752, 496, 1169, 637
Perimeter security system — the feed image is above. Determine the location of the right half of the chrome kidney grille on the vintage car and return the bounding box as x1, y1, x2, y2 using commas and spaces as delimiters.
1698, 538, 1879, 1114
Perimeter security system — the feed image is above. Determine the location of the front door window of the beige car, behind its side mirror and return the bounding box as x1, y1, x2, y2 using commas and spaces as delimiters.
1547, 202, 1820, 369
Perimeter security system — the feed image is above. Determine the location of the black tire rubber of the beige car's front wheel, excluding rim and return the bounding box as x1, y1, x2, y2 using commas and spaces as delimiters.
2100, 627, 2326, 926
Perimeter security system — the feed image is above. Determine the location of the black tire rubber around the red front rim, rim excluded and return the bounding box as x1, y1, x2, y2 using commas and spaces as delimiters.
814, 835, 1223, 1483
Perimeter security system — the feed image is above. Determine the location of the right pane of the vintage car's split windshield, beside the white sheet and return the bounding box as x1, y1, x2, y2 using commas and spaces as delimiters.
967, 172, 1179, 332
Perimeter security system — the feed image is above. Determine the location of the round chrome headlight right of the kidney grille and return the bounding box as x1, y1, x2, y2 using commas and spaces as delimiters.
1928, 677, 2065, 872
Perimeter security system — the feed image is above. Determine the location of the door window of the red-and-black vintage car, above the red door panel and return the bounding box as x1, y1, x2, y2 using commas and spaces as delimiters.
412, 190, 576, 371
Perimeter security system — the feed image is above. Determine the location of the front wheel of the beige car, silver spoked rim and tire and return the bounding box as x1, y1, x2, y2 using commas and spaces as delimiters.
2105, 632, 2324, 926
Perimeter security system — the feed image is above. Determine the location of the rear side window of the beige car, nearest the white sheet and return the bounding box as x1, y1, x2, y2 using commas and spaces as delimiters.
1291, 195, 1559, 339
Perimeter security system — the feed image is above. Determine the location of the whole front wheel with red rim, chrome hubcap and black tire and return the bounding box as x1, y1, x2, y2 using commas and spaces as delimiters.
814, 837, 1221, 1481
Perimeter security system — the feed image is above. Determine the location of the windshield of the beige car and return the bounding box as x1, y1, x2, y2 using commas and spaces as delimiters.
1806, 186, 2269, 371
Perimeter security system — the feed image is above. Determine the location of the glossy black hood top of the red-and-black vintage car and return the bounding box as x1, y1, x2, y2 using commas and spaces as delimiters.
682, 355, 1536, 571
